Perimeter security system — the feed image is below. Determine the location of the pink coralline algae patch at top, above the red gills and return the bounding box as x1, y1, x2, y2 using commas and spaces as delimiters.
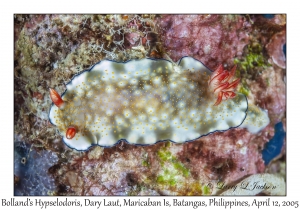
160, 15, 251, 69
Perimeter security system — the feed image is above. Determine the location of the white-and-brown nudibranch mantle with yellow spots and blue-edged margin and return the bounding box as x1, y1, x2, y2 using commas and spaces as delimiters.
49, 57, 248, 150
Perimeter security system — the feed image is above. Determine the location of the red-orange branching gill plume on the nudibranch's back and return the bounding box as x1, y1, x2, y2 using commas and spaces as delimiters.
208, 65, 240, 106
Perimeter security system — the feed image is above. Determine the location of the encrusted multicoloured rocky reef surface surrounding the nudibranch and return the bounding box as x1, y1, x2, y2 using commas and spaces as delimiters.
14, 14, 286, 195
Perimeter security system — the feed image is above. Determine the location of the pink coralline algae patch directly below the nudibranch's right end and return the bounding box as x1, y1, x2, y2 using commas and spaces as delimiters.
179, 127, 269, 183
